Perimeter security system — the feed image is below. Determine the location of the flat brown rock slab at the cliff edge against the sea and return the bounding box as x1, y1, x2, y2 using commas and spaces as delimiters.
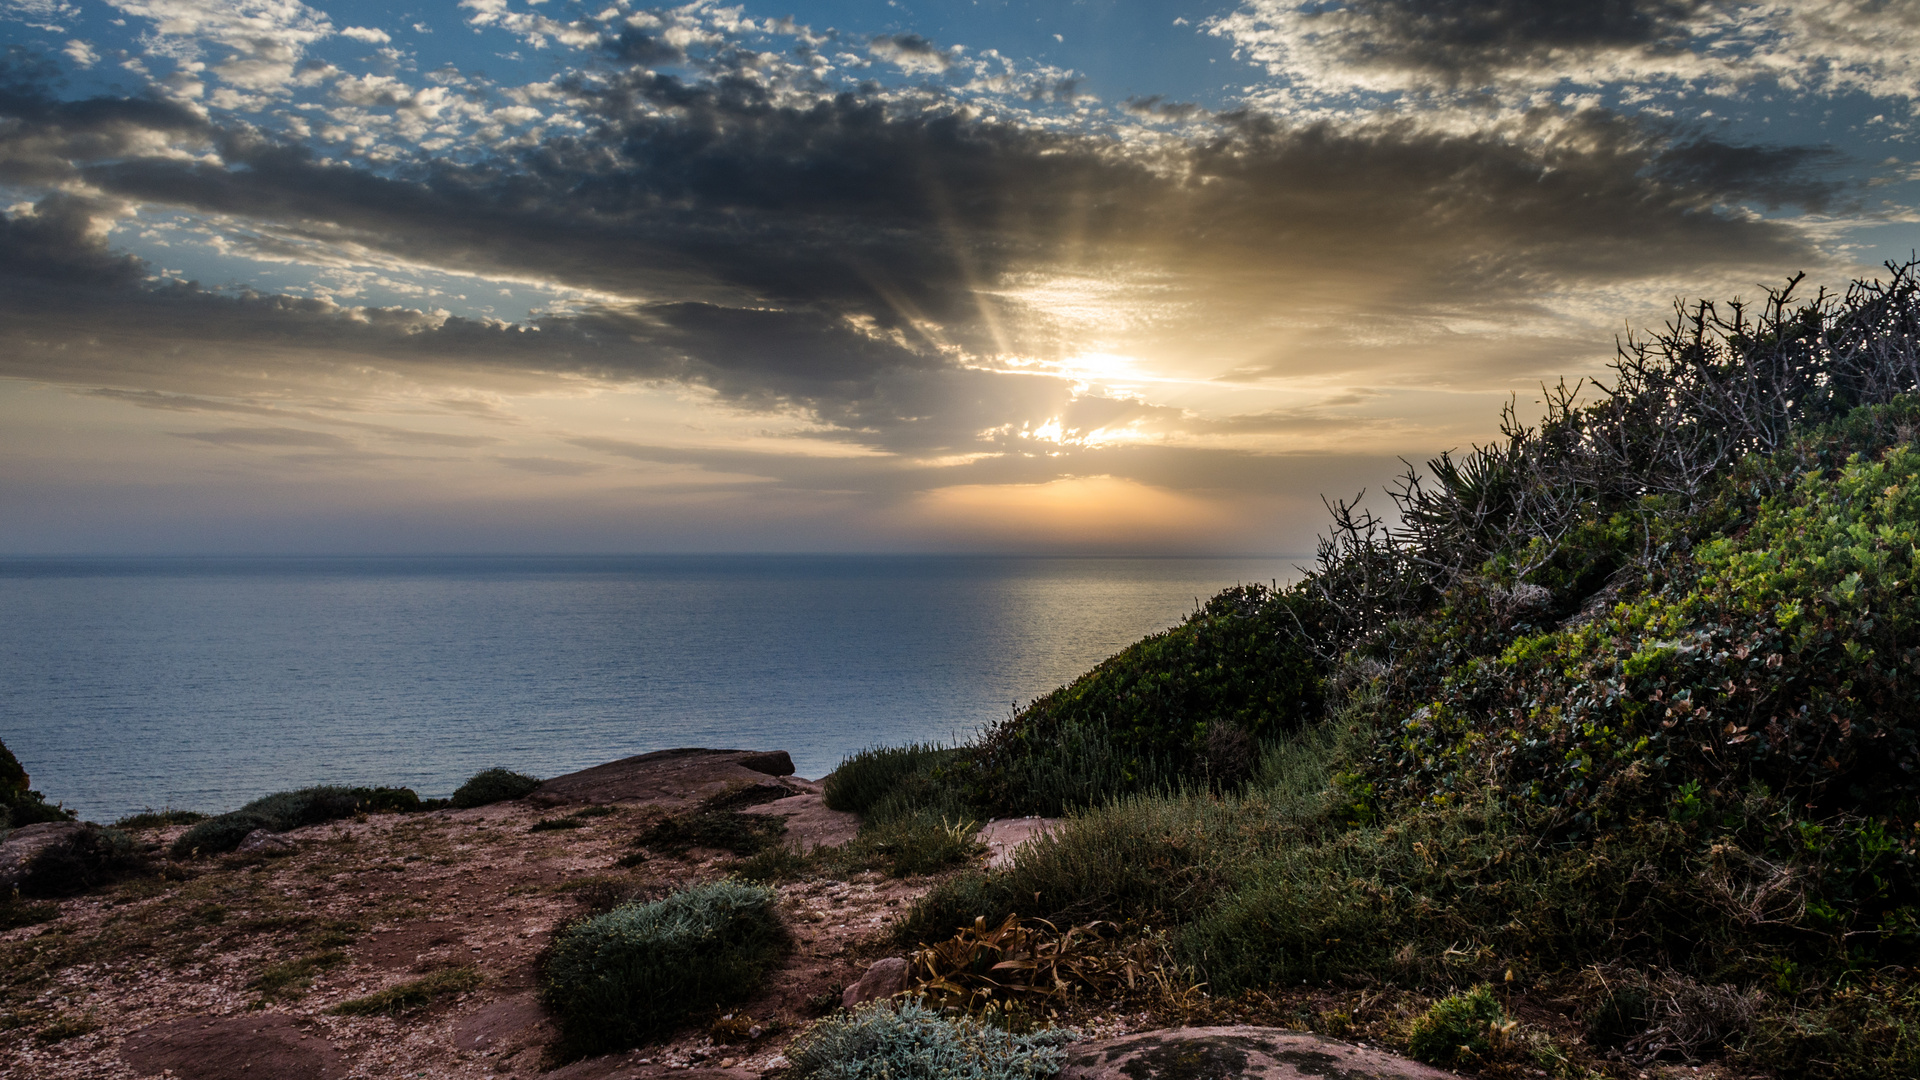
526, 748, 804, 811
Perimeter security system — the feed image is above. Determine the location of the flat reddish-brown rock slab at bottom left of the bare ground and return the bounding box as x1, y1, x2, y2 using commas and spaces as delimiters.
121, 1013, 346, 1080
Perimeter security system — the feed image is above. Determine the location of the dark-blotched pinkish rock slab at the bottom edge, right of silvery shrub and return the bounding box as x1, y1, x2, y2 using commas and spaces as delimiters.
1060, 1026, 1457, 1080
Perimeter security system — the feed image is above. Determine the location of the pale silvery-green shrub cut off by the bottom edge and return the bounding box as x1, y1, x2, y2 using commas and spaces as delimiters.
787, 1003, 1079, 1080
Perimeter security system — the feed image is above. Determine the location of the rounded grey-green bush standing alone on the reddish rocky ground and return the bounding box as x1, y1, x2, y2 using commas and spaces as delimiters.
541, 880, 791, 1057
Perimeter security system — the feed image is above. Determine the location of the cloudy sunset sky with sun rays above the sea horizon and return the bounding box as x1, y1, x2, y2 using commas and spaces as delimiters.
0, 0, 1920, 553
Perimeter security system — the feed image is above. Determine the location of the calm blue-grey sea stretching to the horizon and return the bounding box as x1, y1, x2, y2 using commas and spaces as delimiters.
0, 555, 1292, 821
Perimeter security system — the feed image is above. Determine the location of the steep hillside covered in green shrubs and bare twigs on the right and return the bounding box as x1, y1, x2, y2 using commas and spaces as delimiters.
844, 265, 1920, 1078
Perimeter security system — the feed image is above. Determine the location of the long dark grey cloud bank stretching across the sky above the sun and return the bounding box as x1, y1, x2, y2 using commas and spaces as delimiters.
0, 47, 1832, 452
